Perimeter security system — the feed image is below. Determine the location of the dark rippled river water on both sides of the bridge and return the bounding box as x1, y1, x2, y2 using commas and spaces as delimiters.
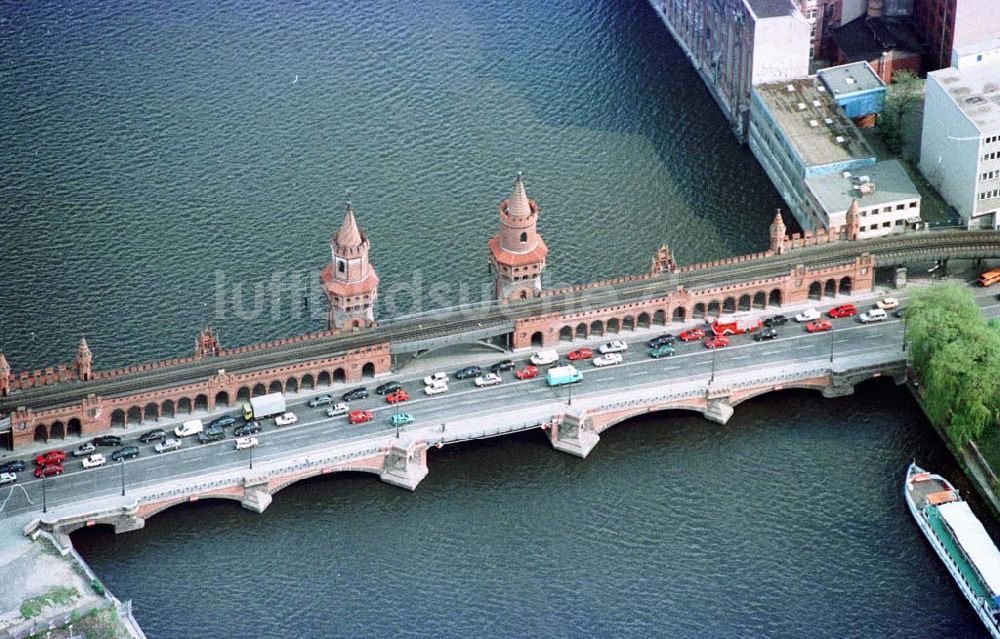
0, 0, 982, 639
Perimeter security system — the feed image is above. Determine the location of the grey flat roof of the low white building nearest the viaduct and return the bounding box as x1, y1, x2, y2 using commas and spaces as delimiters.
806, 160, 920, 218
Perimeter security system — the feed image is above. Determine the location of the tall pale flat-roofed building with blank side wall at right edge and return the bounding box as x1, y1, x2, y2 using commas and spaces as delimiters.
920, 61, 1000, 228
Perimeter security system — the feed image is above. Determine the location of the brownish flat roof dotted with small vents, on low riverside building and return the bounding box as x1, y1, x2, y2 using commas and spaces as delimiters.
754, 77, 875, 175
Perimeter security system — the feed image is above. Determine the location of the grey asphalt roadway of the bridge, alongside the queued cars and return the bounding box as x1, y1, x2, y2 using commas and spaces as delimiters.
0, 294, 1000, 517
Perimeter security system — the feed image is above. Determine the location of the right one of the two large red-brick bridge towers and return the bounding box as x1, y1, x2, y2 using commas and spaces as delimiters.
489, 171, 549, 301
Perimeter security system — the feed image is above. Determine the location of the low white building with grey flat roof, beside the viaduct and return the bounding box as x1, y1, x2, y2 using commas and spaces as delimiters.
806, 160, 920, 238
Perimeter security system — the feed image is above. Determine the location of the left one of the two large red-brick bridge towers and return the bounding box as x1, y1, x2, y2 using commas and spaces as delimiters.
320, 202, 378, 331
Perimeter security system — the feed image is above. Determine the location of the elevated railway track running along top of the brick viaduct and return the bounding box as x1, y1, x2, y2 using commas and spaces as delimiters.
0, 230, 1000, 413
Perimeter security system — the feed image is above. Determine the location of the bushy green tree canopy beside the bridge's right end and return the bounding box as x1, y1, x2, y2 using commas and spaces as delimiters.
906, 284, 1000, 445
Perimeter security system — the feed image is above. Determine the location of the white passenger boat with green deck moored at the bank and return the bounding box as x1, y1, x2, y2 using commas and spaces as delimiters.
903, 464, 1000, 639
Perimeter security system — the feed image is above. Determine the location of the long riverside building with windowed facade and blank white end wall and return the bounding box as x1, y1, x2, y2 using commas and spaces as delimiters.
650, 0, 810, 142
